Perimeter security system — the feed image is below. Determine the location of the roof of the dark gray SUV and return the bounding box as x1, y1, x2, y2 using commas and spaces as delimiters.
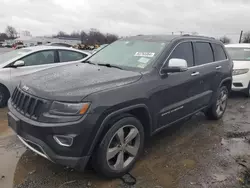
122, 35, 215, 42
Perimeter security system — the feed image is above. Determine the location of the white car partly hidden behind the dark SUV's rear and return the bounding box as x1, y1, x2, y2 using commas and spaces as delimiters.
226, 44, 250, 97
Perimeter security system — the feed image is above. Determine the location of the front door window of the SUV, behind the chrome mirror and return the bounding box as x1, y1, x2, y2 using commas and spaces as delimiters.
169, 42, 194, 67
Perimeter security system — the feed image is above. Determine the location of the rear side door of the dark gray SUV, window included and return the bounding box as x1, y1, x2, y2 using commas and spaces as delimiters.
192, 41, 216, 110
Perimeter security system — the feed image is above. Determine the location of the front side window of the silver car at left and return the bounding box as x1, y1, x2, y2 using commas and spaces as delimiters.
21, 50, 55, 66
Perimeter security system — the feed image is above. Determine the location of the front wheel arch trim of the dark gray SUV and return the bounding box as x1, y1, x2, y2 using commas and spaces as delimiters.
88, 104, 152, 155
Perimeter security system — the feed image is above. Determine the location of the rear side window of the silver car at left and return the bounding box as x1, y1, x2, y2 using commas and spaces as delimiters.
59, 50, 87, 62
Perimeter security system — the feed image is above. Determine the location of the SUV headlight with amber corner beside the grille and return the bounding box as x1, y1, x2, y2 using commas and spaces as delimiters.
49, 101, 90, 116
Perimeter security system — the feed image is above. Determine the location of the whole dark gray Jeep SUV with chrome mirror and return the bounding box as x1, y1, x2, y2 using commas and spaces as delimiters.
8, 36, 233, 177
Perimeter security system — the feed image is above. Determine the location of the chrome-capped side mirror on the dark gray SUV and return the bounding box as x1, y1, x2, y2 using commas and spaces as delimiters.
161, 58, 188, 74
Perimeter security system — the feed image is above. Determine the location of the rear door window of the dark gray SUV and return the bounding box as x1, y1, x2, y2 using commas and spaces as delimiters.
195, 42, 214, 65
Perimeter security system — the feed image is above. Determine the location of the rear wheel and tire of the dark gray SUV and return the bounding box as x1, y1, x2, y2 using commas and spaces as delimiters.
205, 86, 229, 120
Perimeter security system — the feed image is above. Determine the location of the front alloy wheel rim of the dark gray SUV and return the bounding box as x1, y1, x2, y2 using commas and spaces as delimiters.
106, 125, 140, 171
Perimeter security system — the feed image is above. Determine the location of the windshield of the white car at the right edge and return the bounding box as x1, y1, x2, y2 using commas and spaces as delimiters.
227, 48, 250, 61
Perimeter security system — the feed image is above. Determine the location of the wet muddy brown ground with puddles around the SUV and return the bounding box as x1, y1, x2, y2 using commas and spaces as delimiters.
0, 94, 250, 188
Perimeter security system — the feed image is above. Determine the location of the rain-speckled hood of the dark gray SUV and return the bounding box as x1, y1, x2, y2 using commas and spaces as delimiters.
20, 63, 141, 101
